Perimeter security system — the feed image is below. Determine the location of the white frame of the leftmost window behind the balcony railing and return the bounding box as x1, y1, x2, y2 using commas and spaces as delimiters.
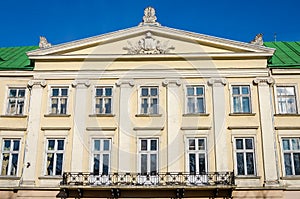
90, 137, 112, 176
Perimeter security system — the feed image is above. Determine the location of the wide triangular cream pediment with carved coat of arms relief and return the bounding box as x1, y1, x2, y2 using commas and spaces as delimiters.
28, 25, 274, 59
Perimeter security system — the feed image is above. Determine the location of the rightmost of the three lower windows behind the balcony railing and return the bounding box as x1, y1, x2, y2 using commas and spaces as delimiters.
187, 138, 207, 174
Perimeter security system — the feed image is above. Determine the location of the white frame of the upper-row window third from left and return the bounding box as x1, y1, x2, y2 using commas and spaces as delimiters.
92, 85, 115, 115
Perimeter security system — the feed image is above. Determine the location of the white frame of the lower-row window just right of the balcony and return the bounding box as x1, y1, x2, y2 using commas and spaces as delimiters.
233, 136, 257, 176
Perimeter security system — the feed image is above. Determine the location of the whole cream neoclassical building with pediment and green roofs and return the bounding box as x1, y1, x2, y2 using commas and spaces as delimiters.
0, 7, 300, 198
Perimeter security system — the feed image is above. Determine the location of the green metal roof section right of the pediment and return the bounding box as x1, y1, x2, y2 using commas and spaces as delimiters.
264, 41, 300, 68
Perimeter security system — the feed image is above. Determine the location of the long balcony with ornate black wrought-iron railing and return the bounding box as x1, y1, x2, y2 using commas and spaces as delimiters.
57, 172, 235, 198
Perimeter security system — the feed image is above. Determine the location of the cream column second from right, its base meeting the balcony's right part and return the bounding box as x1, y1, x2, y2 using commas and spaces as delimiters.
208, 78, 230, 172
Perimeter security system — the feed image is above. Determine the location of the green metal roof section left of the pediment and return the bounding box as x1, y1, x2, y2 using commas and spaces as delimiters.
0, 46, 39, 70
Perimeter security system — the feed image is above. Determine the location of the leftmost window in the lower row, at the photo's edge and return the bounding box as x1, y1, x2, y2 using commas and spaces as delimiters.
0, 139, 20, 176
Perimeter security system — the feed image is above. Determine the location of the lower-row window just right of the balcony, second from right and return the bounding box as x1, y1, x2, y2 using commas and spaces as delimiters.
235, 138, 256, 175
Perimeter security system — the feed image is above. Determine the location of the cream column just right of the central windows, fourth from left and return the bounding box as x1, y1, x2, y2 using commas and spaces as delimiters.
163, 80, 185, 172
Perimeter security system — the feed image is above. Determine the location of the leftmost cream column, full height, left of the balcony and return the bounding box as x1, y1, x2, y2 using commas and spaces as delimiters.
21, 80, 46, 186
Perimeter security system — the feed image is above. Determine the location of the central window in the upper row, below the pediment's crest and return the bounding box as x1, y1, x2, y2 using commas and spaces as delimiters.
141, 87, 158, 114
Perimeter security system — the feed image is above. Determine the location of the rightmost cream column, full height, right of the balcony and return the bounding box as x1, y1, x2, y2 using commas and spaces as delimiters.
254, 78, 278, 186
